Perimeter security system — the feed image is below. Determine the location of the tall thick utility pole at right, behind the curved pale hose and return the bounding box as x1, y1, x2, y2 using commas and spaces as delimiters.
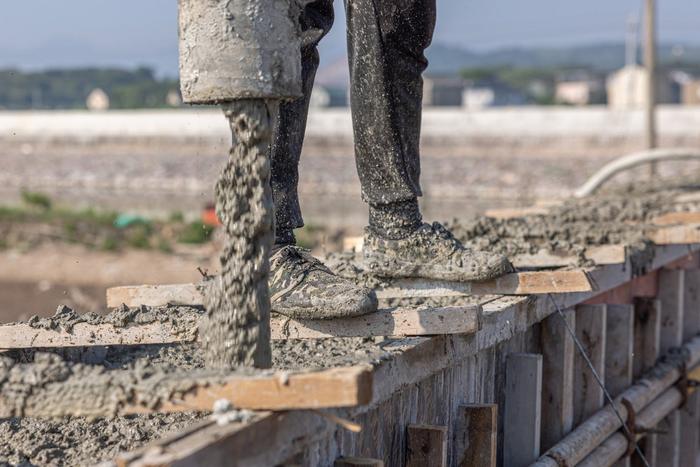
644, 0, 658, 176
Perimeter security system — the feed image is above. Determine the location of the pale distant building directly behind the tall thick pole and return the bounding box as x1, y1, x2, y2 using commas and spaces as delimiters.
607, 65, 674, 110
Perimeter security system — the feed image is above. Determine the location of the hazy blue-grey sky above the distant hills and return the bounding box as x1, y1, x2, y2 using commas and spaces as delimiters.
0, 0, 700, 76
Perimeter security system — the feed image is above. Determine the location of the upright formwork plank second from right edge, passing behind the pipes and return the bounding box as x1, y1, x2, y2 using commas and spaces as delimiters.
657, 269, 685, 467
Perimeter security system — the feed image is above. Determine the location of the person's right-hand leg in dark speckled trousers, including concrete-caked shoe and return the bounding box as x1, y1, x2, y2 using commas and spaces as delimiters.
345, 0, 510, 280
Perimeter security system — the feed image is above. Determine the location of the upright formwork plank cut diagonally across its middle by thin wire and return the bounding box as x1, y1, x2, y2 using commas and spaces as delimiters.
574, 305, 607, 426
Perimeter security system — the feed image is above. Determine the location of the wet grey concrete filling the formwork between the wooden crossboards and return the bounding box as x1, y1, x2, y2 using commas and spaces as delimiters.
0, 181, 698, 466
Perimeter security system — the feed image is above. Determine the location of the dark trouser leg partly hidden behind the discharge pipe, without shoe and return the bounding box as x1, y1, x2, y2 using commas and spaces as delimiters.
270, 0, 333, 245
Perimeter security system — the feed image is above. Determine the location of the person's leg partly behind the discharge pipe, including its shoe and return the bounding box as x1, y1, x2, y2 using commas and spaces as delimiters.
270, 0, 377, 319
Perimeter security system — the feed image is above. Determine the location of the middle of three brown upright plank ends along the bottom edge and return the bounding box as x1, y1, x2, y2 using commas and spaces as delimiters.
406, 425, 447, 467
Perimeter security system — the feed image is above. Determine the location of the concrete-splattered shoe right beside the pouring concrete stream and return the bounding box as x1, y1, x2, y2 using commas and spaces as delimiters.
270, 245, 377, 319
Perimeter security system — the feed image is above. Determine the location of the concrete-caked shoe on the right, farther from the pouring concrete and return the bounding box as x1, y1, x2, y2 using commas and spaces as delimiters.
363, 222, 513, 282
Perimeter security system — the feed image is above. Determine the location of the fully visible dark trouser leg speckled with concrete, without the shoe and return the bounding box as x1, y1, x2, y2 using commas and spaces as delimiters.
345, 0, 435, 237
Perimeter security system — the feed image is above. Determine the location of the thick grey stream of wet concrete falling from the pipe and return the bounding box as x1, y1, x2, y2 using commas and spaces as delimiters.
200, 99, 277, 369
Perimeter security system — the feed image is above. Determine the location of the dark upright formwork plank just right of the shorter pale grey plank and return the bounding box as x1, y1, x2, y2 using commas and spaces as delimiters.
540, 308, 576, 451
